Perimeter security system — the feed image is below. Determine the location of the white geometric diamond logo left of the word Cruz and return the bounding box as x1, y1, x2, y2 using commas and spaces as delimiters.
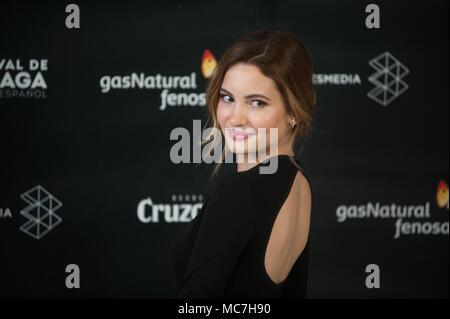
20, 185, 62, 239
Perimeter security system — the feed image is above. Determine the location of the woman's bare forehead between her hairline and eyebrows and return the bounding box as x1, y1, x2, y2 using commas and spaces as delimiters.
222, 63, 277, 95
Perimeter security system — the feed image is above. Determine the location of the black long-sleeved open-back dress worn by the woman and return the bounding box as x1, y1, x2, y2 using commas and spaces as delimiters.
171, 155, 309, 298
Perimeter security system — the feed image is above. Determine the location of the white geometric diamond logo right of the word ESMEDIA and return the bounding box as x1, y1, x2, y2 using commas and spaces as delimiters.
367, 52, 409, 106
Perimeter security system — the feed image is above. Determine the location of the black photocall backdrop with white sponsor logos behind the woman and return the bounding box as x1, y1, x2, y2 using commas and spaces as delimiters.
0, 0, 449, 299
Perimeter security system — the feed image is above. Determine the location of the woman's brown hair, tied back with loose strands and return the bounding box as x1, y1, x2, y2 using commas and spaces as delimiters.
201, 30, 317, 179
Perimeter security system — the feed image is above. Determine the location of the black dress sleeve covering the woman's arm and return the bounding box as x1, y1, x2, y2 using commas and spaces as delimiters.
176, 176, 255, 298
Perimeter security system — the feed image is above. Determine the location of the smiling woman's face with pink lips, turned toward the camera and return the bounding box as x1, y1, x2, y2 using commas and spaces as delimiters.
217, 63, 293, 158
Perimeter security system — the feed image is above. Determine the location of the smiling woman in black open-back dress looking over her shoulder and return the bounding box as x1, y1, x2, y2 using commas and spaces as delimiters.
172, 30, 316, 298
